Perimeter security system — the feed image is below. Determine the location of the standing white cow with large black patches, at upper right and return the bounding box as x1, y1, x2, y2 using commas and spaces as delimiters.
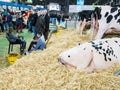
92, 6, 120, 39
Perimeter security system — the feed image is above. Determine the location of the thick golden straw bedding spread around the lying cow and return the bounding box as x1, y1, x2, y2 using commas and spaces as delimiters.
0, 30, 120, 90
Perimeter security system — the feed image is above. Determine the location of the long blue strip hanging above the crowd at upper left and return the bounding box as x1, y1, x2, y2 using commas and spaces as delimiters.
0, 1, 32, 8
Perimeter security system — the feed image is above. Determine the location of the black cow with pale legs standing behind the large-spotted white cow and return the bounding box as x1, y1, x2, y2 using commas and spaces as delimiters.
78, 10, 93, 35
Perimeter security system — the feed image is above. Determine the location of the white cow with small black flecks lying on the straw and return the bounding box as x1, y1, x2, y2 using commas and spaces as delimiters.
58, 38, 120, 73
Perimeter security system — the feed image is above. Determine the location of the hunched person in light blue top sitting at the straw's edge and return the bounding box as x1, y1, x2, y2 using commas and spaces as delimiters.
25, 33, 46, 54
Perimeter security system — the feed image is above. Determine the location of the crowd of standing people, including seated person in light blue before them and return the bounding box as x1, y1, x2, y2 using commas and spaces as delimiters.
0, 9, 71, 52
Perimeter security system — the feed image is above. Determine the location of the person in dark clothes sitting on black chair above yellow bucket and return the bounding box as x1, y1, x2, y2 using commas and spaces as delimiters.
7, 27, 26, 55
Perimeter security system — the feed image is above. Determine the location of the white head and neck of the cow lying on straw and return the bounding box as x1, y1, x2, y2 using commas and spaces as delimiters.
58, 44, 90, 70
